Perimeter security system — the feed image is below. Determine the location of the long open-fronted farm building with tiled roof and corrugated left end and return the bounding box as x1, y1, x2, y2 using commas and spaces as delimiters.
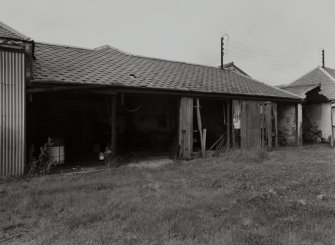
0, 21, 301, 175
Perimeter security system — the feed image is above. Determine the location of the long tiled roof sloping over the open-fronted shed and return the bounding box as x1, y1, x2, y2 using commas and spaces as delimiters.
33, 43, 299, 99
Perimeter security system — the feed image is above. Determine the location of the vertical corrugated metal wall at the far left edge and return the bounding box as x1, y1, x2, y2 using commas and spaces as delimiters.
0, 50, 25, 176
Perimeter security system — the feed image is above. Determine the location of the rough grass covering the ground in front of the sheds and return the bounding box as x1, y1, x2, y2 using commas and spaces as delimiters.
0, 146, 335, 245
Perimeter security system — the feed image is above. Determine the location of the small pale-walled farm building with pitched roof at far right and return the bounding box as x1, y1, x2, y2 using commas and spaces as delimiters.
283, 67, 335, 145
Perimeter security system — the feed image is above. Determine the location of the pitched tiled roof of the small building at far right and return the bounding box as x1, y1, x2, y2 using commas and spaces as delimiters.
284, 67, 335, 100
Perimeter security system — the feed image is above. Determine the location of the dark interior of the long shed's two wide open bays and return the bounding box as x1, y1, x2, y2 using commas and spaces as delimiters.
27, 92, 178, 166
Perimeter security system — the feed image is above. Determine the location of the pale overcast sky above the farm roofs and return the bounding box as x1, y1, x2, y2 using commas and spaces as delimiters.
0, 0, 335, 85
